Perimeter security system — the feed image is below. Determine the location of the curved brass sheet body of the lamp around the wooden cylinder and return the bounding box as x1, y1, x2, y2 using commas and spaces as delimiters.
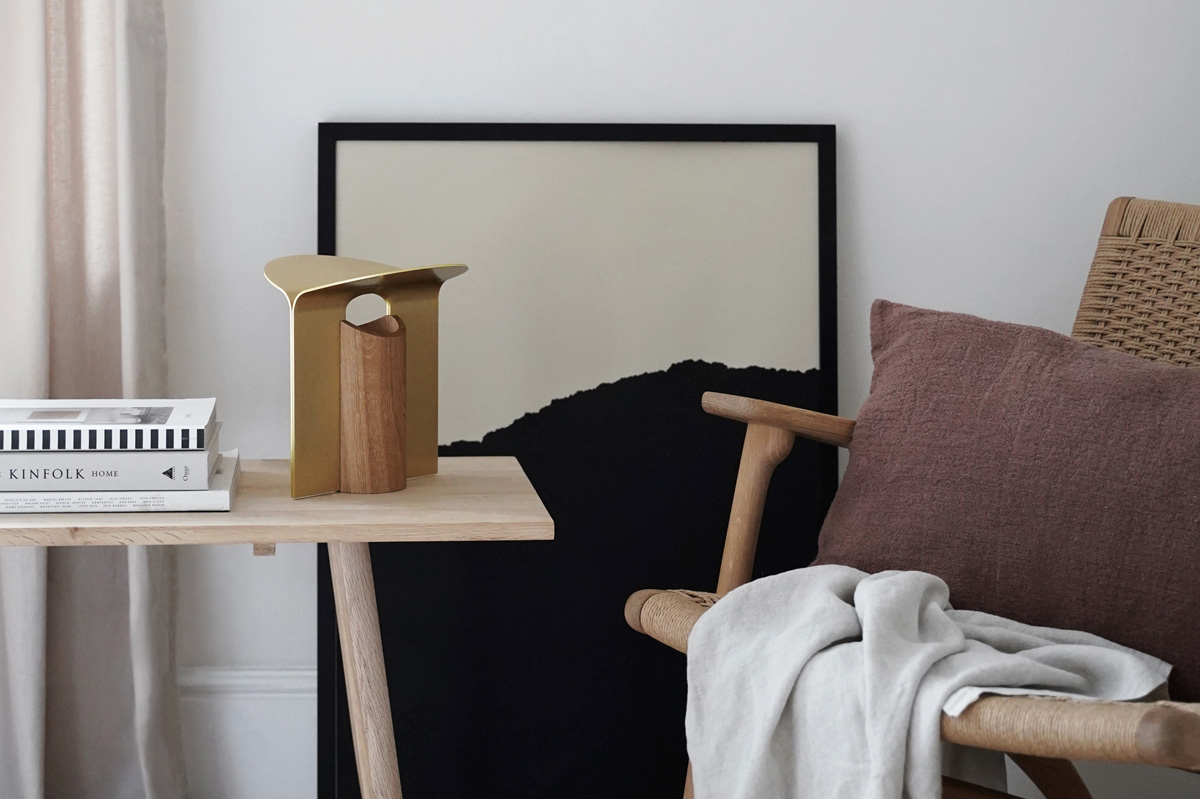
264, 256, 467, 497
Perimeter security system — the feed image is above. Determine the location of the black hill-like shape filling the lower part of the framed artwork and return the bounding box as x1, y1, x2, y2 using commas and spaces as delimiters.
319, 361, 835, 799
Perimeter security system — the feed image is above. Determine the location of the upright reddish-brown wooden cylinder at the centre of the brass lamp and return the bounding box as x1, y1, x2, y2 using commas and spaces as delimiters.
341, 316, 407, 494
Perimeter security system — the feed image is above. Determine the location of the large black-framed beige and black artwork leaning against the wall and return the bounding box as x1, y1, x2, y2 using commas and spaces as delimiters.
318, 124, 836, 799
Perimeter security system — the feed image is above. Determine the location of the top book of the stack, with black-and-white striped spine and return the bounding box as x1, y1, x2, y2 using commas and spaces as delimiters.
0, 397, 216, 452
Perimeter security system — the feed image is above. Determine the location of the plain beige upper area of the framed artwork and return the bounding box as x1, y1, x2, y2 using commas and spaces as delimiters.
336, 142, 818, 444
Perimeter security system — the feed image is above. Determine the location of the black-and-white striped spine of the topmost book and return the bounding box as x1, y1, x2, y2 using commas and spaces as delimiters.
0, 425, 212, 452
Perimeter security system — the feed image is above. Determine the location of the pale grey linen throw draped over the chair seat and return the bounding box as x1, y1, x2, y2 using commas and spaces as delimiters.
686, 565, 1170, 799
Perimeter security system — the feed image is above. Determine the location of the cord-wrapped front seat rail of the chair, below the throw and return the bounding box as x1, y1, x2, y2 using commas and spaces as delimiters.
942, 696, 1200, 771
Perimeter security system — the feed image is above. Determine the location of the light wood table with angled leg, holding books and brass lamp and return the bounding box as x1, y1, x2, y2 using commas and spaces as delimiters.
0, 457, 554, 799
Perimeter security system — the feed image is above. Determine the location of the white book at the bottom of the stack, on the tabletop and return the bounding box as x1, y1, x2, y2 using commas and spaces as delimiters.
0, 450, 241, 513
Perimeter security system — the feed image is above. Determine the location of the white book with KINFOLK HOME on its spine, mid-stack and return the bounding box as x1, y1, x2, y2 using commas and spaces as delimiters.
0, 423, 221, 492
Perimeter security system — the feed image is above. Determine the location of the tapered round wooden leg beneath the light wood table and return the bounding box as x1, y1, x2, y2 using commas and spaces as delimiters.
329, 542, 401, 799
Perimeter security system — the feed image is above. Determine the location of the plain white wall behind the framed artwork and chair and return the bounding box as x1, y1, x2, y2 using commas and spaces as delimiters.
167, 0, 1200, 798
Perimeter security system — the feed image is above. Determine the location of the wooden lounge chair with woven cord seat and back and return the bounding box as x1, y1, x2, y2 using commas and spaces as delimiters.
625, 197, 1200, 799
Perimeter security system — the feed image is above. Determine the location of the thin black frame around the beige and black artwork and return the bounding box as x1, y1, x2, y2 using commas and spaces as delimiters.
317, 122, 838, 799
